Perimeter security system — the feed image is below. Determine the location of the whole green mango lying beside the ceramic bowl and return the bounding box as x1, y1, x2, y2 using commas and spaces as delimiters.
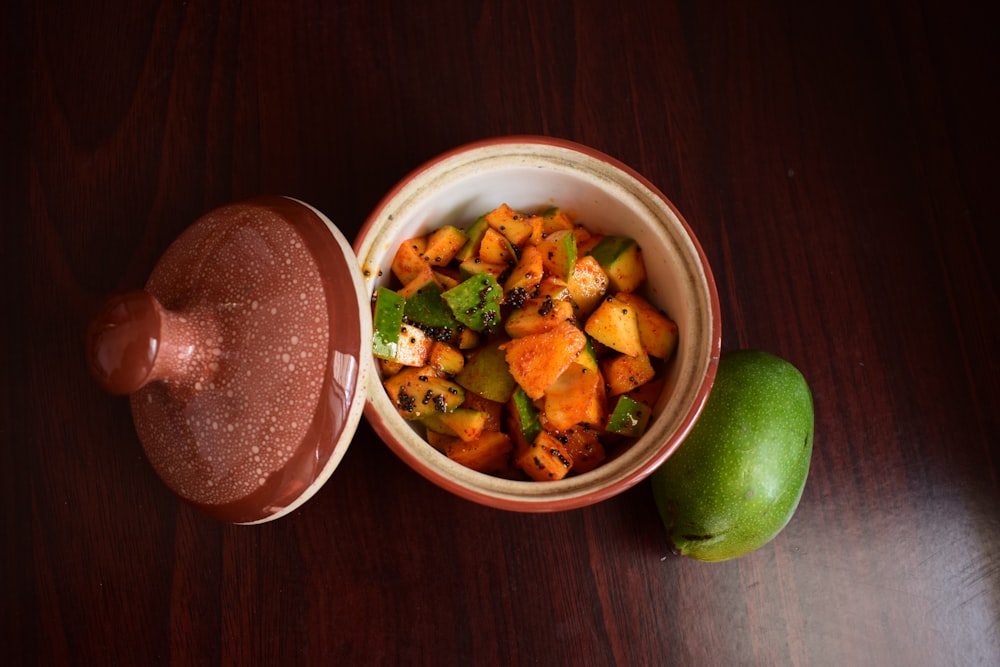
651, 350, 814, 561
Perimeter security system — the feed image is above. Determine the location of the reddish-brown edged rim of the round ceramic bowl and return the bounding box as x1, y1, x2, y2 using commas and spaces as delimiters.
353, 134, 722, 512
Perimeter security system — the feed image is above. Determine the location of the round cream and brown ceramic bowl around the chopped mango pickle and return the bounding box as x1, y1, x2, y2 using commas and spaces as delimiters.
354, 137, 721, 512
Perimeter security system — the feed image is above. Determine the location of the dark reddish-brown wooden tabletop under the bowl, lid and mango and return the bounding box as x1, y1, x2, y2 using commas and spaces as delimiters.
0, 0, 1000, 665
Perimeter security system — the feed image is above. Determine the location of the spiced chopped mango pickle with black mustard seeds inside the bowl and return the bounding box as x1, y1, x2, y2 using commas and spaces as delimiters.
372, 203, 678, 481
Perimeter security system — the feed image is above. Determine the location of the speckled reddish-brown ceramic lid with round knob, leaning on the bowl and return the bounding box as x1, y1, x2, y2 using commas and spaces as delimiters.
87, 197, 371, 523
